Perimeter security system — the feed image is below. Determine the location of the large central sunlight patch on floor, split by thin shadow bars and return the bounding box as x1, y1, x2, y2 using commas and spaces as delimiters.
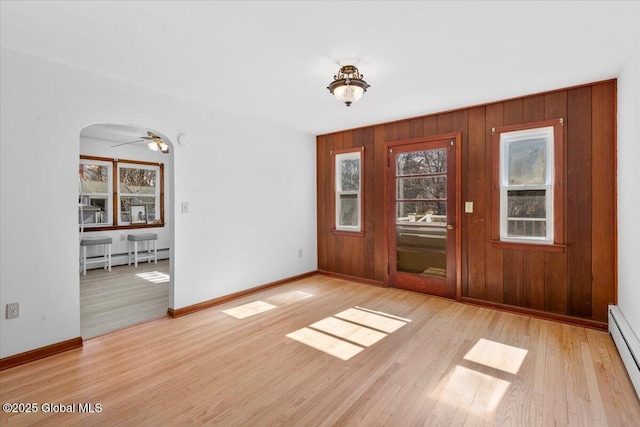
287, 307, 411, 360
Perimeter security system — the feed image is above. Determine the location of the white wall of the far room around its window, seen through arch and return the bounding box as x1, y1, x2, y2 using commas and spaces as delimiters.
80, 137, 176, 268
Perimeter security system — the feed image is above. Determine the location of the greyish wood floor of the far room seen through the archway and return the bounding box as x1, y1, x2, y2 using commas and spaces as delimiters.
80, 260, 169, 340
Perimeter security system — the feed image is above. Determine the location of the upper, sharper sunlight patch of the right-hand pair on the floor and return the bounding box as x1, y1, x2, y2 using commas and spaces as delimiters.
464, 338, 527, 375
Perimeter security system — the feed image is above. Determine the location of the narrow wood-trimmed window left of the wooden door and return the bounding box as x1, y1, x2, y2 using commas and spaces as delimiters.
332, 147, 364, 232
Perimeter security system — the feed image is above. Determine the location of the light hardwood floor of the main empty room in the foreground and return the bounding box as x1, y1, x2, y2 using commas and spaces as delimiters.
0, 276, 640, 426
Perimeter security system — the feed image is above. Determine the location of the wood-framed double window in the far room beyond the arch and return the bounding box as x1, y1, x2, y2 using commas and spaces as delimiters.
78, 156, 164, 230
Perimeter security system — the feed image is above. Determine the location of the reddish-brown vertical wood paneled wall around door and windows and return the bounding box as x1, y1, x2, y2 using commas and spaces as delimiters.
317, 80, 617, 323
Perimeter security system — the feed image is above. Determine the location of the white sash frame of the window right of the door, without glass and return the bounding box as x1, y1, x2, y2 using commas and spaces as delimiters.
499, 126, 556, 245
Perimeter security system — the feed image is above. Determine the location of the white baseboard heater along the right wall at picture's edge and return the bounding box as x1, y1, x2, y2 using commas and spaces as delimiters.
609, 305, 640, 397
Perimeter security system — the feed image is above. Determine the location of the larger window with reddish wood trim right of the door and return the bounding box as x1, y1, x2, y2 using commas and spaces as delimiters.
492, 119, 564, 249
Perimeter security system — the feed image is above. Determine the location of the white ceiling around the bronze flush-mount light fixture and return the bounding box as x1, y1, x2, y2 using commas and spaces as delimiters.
0, 0, 640, 135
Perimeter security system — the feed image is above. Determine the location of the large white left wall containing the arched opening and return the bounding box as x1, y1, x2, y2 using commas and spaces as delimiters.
0, 49, 317, 357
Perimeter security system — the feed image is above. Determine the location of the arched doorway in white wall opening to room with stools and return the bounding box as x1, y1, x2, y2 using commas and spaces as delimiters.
78, 123, 174, 339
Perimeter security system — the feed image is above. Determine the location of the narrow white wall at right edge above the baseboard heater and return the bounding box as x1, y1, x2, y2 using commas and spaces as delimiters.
618, 54, 640, 337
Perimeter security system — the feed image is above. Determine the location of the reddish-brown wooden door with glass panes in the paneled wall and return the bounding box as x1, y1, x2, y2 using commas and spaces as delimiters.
387, 137, 458, 298
